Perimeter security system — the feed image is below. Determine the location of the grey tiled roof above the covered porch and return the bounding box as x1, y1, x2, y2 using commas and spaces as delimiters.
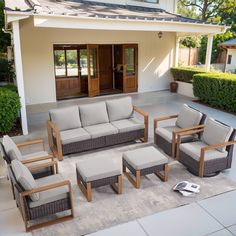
5, 0, 223, 24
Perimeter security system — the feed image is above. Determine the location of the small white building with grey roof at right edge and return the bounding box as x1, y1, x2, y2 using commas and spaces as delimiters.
218, 38, 236, 73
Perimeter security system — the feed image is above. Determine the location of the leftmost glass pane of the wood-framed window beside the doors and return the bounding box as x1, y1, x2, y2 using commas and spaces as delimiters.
54, 50, 66, 77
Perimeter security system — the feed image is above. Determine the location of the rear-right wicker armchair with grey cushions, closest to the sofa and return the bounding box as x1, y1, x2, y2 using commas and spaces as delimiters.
154, 104, 206, 158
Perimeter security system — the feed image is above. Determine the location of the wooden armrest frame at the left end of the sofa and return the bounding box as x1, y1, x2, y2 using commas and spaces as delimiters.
47, 120, 63, 161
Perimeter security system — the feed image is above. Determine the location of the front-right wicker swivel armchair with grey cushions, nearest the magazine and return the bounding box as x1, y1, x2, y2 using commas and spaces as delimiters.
176, 119, 236, 177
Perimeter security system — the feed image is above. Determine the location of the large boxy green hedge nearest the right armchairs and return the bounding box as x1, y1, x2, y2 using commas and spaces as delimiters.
193, 73, 236, 112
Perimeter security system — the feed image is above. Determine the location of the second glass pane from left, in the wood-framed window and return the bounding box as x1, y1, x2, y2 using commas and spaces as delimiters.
66, 50, 78, 76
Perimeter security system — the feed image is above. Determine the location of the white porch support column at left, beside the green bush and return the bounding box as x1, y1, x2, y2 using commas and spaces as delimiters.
12, 21, 28, 135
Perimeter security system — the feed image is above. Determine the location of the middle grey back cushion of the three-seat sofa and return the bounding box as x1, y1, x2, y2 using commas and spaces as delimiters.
80, 102, 109, 127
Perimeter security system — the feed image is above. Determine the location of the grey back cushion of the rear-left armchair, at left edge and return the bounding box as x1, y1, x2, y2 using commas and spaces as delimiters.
3, 135, 22, 161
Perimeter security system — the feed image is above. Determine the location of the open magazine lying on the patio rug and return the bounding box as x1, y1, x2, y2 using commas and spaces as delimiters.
173, 181, 200, 197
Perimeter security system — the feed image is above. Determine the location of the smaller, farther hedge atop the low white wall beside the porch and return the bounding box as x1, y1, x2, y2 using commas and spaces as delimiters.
171, 67, 204, 83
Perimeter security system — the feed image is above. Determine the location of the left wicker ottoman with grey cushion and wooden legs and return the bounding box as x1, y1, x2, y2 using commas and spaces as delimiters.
76, 158, 122, 202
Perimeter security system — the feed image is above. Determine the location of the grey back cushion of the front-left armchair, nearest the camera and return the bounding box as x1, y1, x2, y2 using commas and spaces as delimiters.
11, 160, 39, 201
